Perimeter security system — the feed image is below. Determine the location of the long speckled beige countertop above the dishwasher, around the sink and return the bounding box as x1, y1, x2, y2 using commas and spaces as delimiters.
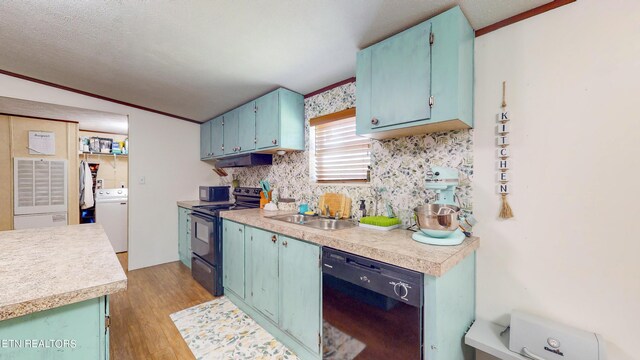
220, 209, 480, 277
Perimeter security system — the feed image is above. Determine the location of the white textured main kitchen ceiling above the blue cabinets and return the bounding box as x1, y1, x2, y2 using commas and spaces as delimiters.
0, 0, 550, 121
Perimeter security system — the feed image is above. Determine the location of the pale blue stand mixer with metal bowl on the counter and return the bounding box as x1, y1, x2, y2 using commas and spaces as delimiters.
412, 166, 465, 245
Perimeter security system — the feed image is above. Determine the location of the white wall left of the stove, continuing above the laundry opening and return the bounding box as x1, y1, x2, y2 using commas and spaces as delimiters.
0, 75, 219, 270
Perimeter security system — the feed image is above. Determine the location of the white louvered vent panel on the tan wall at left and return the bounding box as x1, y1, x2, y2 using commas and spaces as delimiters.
13, 158, 67, 215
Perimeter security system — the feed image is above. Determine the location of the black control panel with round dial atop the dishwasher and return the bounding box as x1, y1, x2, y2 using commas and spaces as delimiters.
322, 247, 423, 306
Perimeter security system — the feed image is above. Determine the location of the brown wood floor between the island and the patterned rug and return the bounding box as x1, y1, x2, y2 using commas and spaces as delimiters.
109, 253, 214, 360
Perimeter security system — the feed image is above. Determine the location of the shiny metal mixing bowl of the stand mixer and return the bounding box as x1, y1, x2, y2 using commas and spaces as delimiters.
413, 204, 460, 238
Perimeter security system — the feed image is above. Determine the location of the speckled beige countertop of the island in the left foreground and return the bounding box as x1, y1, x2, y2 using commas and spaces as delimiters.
0, 224, 127, 320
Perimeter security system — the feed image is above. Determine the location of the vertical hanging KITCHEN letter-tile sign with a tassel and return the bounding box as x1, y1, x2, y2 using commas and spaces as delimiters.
496, 81, 513, 219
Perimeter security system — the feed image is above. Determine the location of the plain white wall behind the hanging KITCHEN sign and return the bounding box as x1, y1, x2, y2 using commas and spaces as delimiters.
474, 0, 640, 360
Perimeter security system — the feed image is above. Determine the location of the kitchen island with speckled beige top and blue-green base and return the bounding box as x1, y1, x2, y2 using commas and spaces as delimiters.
0, 224, 127, 359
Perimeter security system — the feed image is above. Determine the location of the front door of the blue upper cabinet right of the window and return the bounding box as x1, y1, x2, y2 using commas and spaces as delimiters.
369, 22, 431, 128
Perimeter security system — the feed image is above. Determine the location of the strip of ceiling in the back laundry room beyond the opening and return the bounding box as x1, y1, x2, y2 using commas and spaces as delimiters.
0, 96, 129, 135
